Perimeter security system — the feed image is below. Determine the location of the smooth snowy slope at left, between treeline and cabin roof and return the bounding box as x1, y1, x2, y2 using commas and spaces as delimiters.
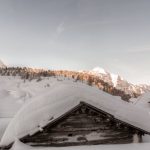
0, 76, 60, 118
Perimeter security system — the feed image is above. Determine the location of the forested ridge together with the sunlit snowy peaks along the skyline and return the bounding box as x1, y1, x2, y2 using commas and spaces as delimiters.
0, 67, 150, 101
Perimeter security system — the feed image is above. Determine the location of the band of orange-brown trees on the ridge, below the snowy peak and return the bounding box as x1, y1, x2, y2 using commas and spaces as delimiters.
0, 67, 134, 101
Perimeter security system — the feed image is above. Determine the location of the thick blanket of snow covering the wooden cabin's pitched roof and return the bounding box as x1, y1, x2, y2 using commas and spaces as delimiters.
1, 82, 150, 146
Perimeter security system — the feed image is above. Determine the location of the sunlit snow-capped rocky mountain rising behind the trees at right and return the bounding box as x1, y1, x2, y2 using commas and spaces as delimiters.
85, 67, 150, 95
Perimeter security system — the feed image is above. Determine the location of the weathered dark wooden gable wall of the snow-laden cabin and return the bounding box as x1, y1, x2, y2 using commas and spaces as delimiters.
20, 102, 146, 146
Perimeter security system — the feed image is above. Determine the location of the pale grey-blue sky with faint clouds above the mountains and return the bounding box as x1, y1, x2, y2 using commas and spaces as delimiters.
0, 0, 150, 84
